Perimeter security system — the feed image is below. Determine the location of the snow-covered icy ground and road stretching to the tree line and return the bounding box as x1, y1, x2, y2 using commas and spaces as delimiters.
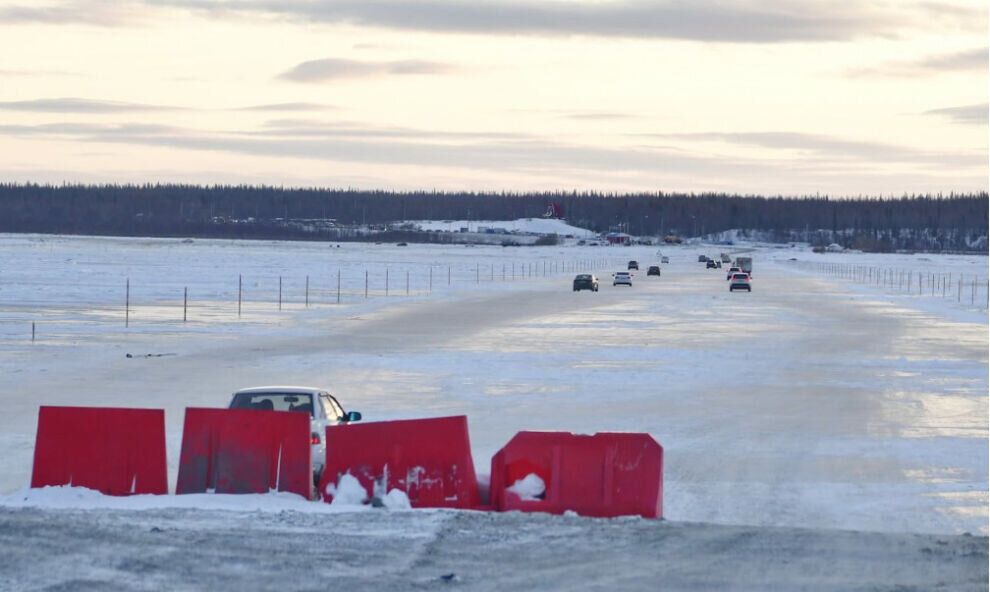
0, 235, 988, 592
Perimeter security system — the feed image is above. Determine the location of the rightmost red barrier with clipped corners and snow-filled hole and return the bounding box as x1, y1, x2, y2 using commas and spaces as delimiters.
491, 432, 663, 518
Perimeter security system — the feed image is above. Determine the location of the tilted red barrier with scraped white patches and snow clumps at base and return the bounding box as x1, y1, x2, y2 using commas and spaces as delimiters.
319, 415, 480, 508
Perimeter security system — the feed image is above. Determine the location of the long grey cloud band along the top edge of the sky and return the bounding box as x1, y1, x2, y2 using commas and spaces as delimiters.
157, 0, 986, 43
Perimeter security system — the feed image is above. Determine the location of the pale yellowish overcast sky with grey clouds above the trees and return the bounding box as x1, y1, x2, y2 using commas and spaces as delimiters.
0, 0, 990, 196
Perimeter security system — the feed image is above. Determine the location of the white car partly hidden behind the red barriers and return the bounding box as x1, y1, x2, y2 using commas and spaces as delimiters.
228, 386, 361, 483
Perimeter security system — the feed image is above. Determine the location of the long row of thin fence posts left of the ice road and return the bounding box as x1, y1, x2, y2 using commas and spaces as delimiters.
95, 260, 608, 328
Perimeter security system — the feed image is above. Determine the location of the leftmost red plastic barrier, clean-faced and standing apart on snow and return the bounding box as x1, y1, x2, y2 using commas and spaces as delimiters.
31, 407, 168, 495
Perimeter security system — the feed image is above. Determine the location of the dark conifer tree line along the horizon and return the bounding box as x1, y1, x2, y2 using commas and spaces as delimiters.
0, 183, 988, 252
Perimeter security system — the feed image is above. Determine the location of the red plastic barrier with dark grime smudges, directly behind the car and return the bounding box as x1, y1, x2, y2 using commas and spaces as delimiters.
175, 408, 313, 499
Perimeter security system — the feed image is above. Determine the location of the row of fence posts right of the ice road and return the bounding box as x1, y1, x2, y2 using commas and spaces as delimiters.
817, 263, 990, 306
